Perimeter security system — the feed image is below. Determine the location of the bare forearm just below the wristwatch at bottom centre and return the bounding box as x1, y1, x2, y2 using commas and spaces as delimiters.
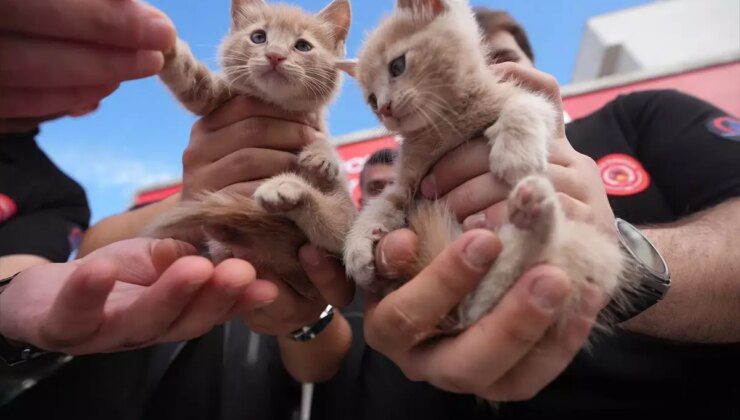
278, 311, 352, 382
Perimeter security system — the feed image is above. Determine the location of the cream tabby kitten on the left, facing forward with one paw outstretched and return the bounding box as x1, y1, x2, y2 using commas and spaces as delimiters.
151, 0, 356, 297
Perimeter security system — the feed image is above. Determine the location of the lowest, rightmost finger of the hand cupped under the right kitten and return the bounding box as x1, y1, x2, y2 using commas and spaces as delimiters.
482, 286, 604, 401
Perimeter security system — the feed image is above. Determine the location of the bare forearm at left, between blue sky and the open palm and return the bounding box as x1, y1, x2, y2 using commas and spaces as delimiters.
77, 193, 180, 258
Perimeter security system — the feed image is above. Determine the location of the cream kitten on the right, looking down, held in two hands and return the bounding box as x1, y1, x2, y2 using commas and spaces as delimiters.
344, 0, 623, 332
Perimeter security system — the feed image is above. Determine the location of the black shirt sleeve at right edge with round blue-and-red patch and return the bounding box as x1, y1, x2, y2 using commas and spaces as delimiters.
617, 90, 740, 217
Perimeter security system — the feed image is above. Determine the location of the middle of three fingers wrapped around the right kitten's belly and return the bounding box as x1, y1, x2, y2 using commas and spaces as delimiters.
442, 172, 511, 220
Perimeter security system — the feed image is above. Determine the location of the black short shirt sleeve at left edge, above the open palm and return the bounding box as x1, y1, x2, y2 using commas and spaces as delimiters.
0, 207, 87, 262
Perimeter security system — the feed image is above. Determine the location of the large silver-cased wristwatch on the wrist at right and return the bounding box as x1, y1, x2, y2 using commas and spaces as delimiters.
604, 218, 671, 324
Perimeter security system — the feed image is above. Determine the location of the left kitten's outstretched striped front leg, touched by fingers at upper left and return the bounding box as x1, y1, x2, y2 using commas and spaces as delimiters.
159, 38, 230, 115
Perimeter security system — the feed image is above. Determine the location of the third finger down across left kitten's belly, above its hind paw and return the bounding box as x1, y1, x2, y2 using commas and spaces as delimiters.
197, 149, 297, 191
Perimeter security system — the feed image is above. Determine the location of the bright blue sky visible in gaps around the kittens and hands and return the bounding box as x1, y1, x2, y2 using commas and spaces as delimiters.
39, 0, 649, 222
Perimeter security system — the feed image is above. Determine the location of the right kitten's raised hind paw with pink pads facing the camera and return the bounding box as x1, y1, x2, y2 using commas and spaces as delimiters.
508, 176, 556, 230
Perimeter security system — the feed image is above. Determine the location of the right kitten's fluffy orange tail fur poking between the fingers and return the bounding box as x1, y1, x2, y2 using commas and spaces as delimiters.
409, 201, 462, 273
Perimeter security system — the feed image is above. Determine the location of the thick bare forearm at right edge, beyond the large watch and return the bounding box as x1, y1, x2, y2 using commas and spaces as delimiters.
624, 199, 740, 343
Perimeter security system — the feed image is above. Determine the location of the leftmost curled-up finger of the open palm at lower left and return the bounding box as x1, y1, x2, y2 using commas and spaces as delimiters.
39, 259, 118, 350
